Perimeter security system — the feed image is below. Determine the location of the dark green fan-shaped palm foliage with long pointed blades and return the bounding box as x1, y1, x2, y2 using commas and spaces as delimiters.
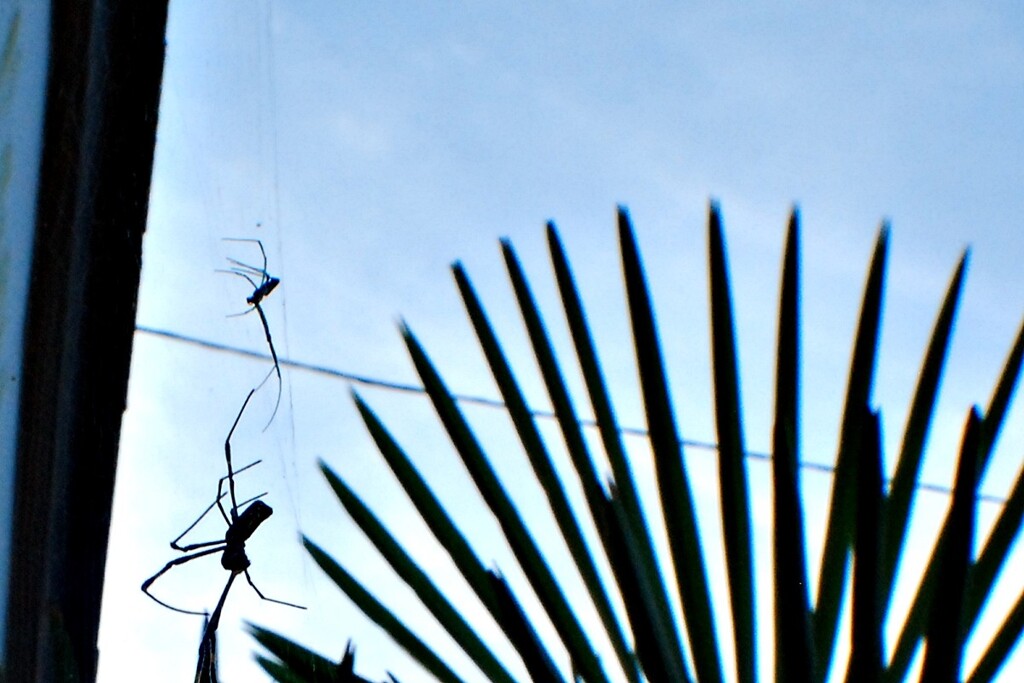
255, 204, 1024, 683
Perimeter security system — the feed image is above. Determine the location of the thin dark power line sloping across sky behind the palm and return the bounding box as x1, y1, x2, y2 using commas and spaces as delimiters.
135, 325, 1007, 506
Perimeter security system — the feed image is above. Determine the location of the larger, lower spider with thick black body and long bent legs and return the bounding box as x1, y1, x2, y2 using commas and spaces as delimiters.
142, 389, 305, 651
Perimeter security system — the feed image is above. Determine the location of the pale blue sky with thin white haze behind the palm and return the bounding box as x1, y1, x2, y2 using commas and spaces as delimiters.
99, 1, 1024, 681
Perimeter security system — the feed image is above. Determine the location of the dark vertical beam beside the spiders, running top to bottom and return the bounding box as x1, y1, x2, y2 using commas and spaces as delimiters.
5, 0, 167, 682
